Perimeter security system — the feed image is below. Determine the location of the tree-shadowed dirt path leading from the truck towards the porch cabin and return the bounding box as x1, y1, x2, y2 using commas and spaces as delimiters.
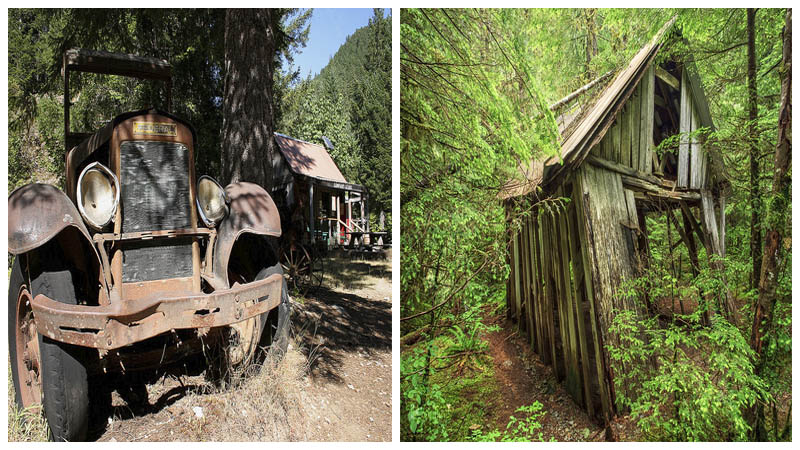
295, 260, 392, 441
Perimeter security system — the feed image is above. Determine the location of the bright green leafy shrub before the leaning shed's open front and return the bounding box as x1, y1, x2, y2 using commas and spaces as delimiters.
608, 311, 768, 441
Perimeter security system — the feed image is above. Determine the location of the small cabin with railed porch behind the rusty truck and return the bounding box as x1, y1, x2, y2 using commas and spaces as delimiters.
271, 133, 369, 248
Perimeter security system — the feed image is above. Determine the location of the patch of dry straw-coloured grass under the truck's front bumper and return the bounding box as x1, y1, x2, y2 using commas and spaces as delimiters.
101, 342, 311, 441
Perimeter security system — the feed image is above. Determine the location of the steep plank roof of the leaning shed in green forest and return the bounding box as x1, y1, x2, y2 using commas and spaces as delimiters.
500, 17, 714, 199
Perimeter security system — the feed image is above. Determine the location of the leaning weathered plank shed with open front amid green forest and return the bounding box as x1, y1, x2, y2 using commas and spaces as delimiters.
502, 21, 727, 419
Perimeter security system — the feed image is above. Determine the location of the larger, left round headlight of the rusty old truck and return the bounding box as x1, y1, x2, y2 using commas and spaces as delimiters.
78, 162, 119, 230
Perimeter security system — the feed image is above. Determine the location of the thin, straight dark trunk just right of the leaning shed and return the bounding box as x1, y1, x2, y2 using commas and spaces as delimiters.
747, 8, 762, 289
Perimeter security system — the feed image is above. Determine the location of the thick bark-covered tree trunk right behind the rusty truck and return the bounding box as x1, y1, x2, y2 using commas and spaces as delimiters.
221, 9, 280, 191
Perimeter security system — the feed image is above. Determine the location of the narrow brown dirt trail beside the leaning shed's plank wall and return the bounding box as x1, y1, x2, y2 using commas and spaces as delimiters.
487, 317, 604, 441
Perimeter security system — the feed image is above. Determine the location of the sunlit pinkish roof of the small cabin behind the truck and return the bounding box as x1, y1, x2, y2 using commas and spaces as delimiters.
275, 133, 347, 183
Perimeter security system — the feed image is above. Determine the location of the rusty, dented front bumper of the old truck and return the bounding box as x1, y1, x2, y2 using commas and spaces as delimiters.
31, 274, 283, 350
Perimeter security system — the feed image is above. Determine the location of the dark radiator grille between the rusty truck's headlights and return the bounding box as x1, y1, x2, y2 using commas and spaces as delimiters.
120, 141, 192, 283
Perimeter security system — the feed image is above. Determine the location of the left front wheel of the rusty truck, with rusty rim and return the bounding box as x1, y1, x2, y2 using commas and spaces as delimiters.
8, 258, 89, 441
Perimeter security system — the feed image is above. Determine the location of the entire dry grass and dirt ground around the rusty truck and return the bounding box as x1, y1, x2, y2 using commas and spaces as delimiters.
8, 258, 392, 442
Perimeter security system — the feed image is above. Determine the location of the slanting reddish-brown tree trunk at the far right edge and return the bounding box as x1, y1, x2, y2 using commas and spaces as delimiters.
751, 9, 792, 440
